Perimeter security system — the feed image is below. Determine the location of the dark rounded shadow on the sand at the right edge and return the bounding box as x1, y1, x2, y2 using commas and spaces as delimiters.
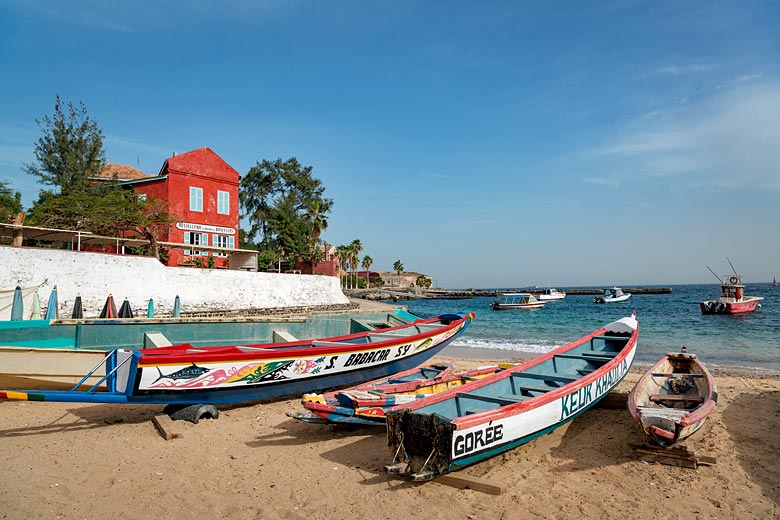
721, 391, 780, 502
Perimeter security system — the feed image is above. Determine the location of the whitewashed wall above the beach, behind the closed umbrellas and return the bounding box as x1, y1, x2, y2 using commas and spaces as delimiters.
0, 246, 349, 318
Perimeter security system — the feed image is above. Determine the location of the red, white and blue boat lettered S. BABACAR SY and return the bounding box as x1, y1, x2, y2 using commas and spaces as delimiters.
0, 313, 474, 405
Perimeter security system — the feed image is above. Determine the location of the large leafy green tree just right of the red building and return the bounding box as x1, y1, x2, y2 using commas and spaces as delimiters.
239, 157, 333, 261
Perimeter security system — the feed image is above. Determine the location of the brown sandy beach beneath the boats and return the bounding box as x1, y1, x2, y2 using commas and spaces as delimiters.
0, 349, 780, 520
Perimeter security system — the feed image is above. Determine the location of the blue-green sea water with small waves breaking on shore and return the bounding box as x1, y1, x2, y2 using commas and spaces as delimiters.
403, 283, 780, 375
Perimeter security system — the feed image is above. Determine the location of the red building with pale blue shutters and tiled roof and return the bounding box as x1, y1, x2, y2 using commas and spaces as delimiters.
101, 147, 241, 267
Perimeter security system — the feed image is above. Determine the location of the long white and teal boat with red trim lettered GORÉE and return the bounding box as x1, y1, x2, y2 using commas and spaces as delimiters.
386, 313, 639, 480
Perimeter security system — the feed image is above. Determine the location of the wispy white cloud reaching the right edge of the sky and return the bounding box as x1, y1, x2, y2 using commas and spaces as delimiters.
589, 83, 780, 190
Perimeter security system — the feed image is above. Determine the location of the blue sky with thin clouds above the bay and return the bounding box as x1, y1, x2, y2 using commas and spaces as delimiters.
0, 0, 780, 288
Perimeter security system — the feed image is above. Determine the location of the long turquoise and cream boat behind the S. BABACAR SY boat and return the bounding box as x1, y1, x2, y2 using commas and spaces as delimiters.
0, 308, 419, 389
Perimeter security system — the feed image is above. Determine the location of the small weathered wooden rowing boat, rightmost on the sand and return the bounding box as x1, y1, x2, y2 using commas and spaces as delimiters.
628, 352, 718, 446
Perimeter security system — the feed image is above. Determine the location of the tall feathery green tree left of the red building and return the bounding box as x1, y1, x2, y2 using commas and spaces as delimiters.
22, 96, 105, 194
